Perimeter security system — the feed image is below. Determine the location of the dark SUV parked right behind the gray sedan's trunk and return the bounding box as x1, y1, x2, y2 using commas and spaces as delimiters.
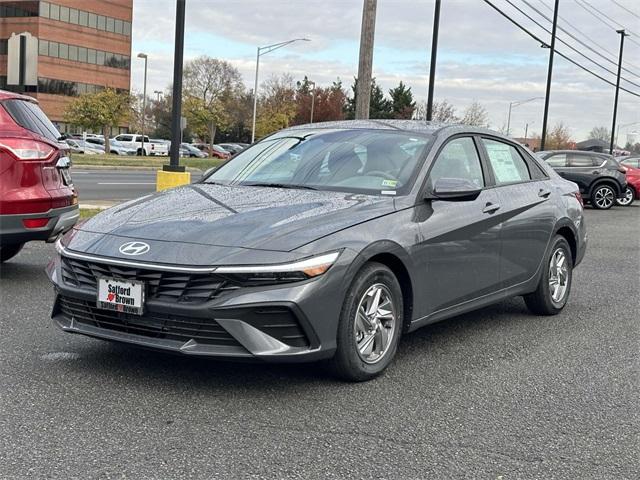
538, 150, 627, 210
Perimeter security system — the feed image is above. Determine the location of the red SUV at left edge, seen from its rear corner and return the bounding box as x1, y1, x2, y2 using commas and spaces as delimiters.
0, 90, 79, 262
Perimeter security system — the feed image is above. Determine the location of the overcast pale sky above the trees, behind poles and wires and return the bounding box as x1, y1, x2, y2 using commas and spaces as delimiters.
132, 0, 640, 143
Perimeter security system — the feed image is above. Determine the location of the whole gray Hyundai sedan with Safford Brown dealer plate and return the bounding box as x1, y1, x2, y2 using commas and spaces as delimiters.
48, 121, 587, 381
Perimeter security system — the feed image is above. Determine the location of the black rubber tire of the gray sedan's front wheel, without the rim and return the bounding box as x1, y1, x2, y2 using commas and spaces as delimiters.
329, 262, 404, 382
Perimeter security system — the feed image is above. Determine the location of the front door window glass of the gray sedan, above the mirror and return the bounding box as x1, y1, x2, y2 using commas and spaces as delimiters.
429, 137, 485, 188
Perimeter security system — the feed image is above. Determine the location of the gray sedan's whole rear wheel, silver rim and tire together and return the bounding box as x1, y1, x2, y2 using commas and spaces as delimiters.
524, 235, 573, 315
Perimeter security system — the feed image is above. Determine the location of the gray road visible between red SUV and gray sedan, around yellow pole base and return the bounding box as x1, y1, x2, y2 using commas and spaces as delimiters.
71, 167, 201, 205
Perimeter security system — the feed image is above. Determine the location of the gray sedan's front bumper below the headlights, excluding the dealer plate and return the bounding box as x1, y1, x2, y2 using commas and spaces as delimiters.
47, 249, 356, 362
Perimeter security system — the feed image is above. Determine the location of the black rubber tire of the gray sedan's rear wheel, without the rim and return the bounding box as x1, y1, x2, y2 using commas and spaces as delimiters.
524, 235, 574, 315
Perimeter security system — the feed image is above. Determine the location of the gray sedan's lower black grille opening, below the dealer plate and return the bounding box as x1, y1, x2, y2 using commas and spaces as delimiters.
59, 295, 241, 346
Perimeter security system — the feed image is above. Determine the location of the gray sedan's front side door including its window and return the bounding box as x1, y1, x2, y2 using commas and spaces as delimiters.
416, 136, 500, 315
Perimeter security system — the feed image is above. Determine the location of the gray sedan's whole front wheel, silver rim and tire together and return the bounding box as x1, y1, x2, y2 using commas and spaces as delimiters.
330, 263, 403, 382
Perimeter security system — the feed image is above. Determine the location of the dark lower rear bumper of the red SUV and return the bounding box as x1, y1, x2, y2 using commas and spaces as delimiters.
0, 205, 80, 245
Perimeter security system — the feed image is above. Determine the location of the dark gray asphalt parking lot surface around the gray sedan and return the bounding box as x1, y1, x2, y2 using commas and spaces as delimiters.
0, 206, 640, 480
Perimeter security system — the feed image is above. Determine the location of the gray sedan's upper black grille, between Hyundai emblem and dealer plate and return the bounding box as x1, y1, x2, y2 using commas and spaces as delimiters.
62, 257, 242, 303
